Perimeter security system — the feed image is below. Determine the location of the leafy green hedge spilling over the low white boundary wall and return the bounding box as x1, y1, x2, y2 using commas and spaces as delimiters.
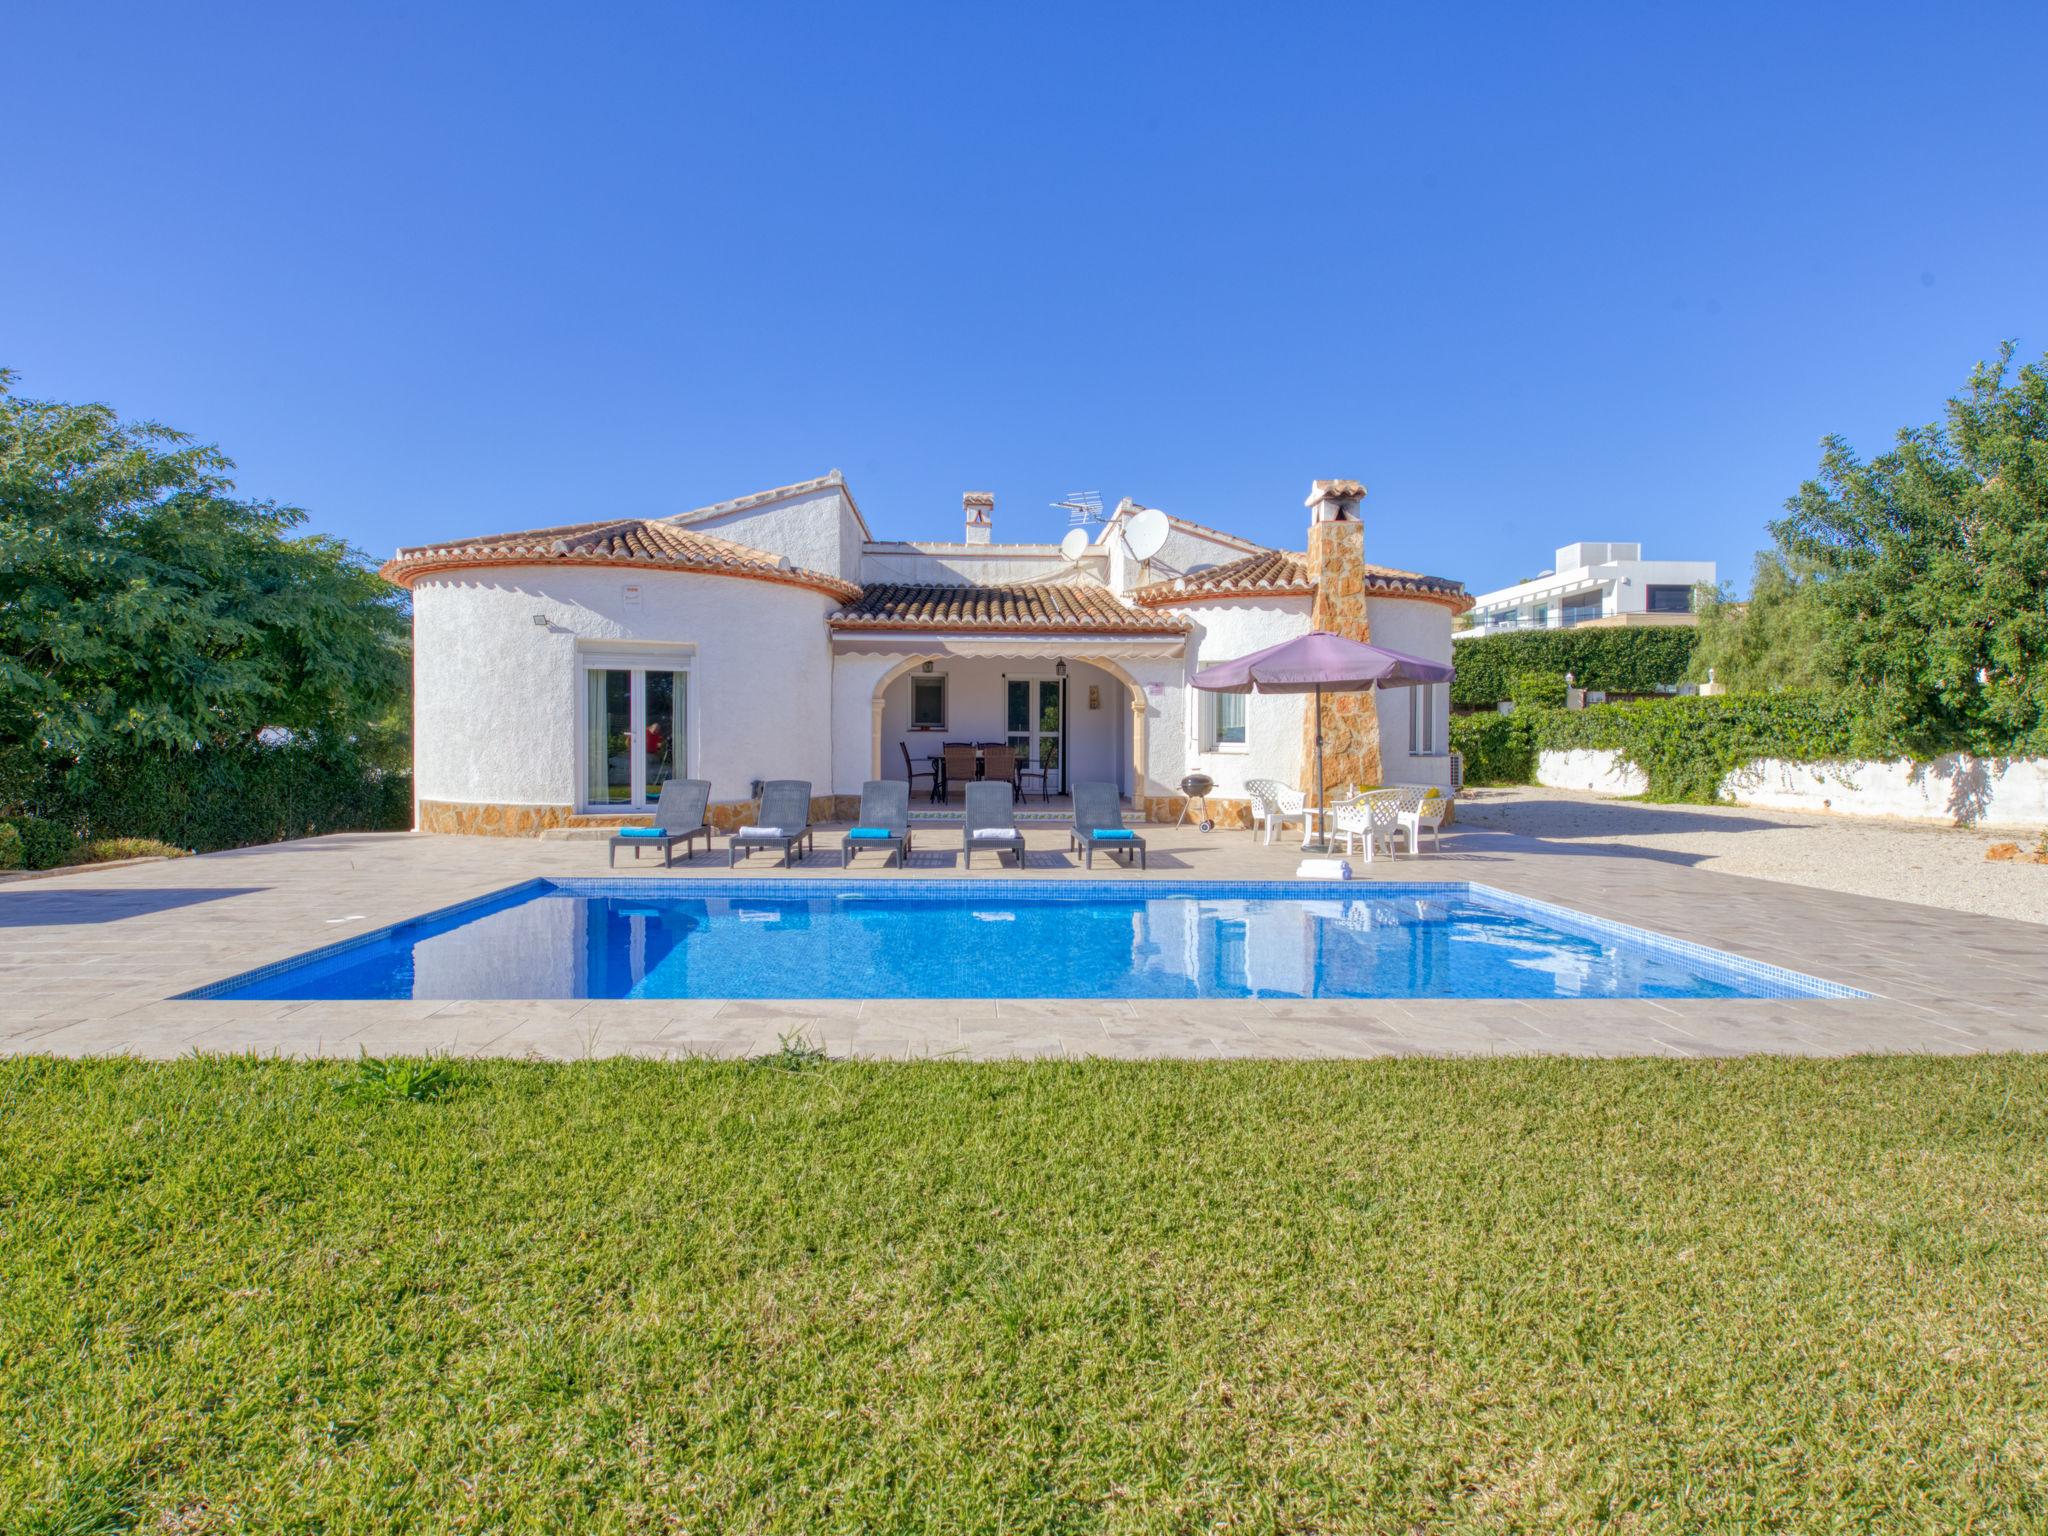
1450, 692, 1853, 801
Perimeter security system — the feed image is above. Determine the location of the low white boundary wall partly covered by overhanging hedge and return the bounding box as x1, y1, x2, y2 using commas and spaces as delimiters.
1536, 750, 2048, 827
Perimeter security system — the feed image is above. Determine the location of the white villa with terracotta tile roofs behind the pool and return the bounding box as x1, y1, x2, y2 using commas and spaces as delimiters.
383, 471, 1470, 836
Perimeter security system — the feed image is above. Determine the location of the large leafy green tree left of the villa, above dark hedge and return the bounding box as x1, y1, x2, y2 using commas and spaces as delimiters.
0, 371, 408, 764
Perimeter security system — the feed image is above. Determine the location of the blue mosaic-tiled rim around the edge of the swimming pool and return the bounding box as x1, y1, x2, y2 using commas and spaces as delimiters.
166, 874, 1878, 1006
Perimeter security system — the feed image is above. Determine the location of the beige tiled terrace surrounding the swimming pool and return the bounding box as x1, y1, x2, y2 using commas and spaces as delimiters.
0, 827, 2048, 1059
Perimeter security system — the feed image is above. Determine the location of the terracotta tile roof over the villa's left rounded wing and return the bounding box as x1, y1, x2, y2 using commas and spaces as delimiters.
383, 518, 860, 598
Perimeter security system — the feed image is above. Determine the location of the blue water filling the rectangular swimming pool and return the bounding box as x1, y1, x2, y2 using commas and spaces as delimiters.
190, 879, 1860, 999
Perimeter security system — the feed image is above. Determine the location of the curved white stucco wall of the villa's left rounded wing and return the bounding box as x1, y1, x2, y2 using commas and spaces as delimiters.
414, 567, 835, 805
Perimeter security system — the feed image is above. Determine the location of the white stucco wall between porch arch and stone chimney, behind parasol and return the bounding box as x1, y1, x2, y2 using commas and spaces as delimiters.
1161, 598, 1313, 799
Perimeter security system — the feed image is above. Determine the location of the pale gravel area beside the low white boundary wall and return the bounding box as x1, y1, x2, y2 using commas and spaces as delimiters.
1458, 788, 2048, 924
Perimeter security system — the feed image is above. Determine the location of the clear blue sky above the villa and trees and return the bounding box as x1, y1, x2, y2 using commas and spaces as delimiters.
0, 4, 2048, 590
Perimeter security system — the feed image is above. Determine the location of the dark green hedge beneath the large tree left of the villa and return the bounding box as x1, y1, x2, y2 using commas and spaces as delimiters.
10, 741, 412, 868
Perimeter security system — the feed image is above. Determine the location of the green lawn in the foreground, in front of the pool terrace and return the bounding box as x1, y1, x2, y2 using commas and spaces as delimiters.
0, 1057, 2048, 1536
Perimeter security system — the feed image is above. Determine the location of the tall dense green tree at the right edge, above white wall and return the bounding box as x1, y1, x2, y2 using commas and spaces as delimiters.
1772, 344, 2048, 756
